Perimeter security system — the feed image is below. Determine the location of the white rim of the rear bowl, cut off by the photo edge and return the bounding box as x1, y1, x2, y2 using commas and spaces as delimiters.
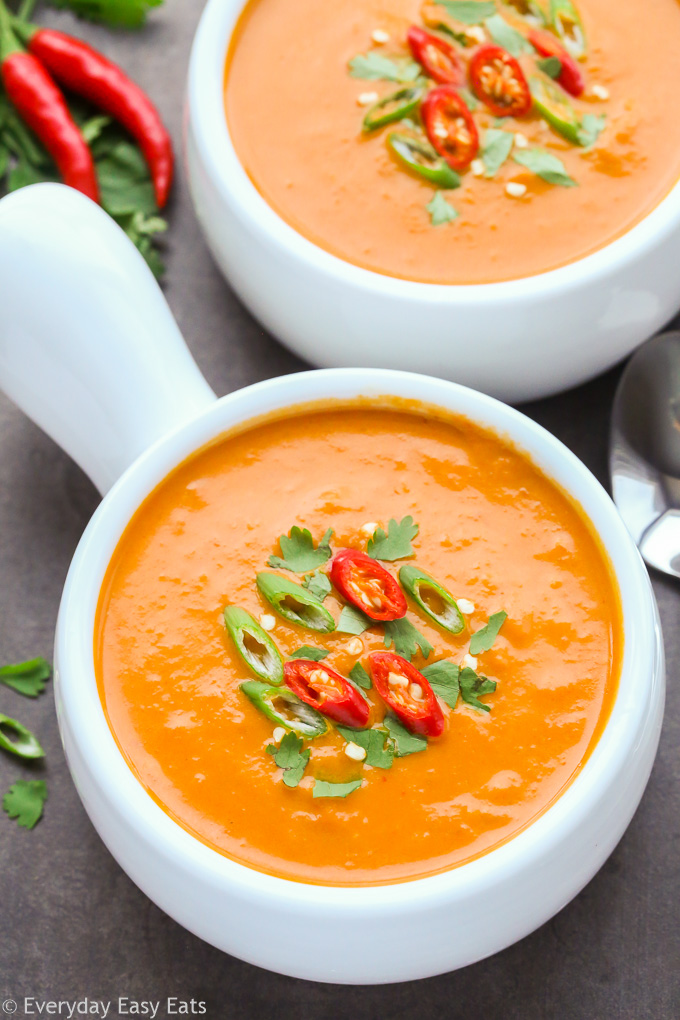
188, 0, 680, 304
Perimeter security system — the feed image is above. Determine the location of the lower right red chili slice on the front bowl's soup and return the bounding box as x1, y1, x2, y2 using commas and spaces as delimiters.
368, 652, 443, 736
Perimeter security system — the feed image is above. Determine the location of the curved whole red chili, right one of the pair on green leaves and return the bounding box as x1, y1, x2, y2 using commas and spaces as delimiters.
19, 26, 174, 209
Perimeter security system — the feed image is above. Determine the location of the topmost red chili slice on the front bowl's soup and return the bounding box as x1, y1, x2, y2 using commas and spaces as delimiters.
330, 549, 407, 620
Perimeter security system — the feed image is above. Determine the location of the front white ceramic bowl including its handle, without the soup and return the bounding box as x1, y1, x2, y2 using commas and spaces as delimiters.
0, 185, 665, 983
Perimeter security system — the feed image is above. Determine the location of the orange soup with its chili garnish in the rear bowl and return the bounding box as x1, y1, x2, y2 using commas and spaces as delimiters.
224, 0, 680, 284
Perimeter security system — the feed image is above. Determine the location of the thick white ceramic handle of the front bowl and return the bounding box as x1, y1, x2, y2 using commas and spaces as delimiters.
0, 184, 215, 494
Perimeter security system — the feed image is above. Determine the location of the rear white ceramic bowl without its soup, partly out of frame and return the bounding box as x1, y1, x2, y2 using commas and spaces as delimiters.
186, 0, 680, 403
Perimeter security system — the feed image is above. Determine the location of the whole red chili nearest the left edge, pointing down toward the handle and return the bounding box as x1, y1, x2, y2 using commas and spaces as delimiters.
0, 6, 99, 202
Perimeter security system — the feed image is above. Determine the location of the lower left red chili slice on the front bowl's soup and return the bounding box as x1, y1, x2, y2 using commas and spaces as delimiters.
283, 659, 370, 729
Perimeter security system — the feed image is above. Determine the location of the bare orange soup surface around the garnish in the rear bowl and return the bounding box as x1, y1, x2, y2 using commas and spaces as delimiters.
225, 0, 680, 284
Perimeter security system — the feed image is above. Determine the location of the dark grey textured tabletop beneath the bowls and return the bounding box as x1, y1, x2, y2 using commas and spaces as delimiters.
0, 0, 680, 1020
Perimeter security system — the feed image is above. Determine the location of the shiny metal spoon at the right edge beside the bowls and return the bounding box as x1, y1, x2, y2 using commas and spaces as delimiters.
610, 332, 680, 577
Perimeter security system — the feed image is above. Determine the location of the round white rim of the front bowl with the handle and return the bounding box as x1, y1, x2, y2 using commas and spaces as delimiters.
57, 368, 659, 916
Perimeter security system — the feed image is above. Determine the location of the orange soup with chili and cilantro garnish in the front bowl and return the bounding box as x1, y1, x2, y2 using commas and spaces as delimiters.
95, 405, 622, 884
